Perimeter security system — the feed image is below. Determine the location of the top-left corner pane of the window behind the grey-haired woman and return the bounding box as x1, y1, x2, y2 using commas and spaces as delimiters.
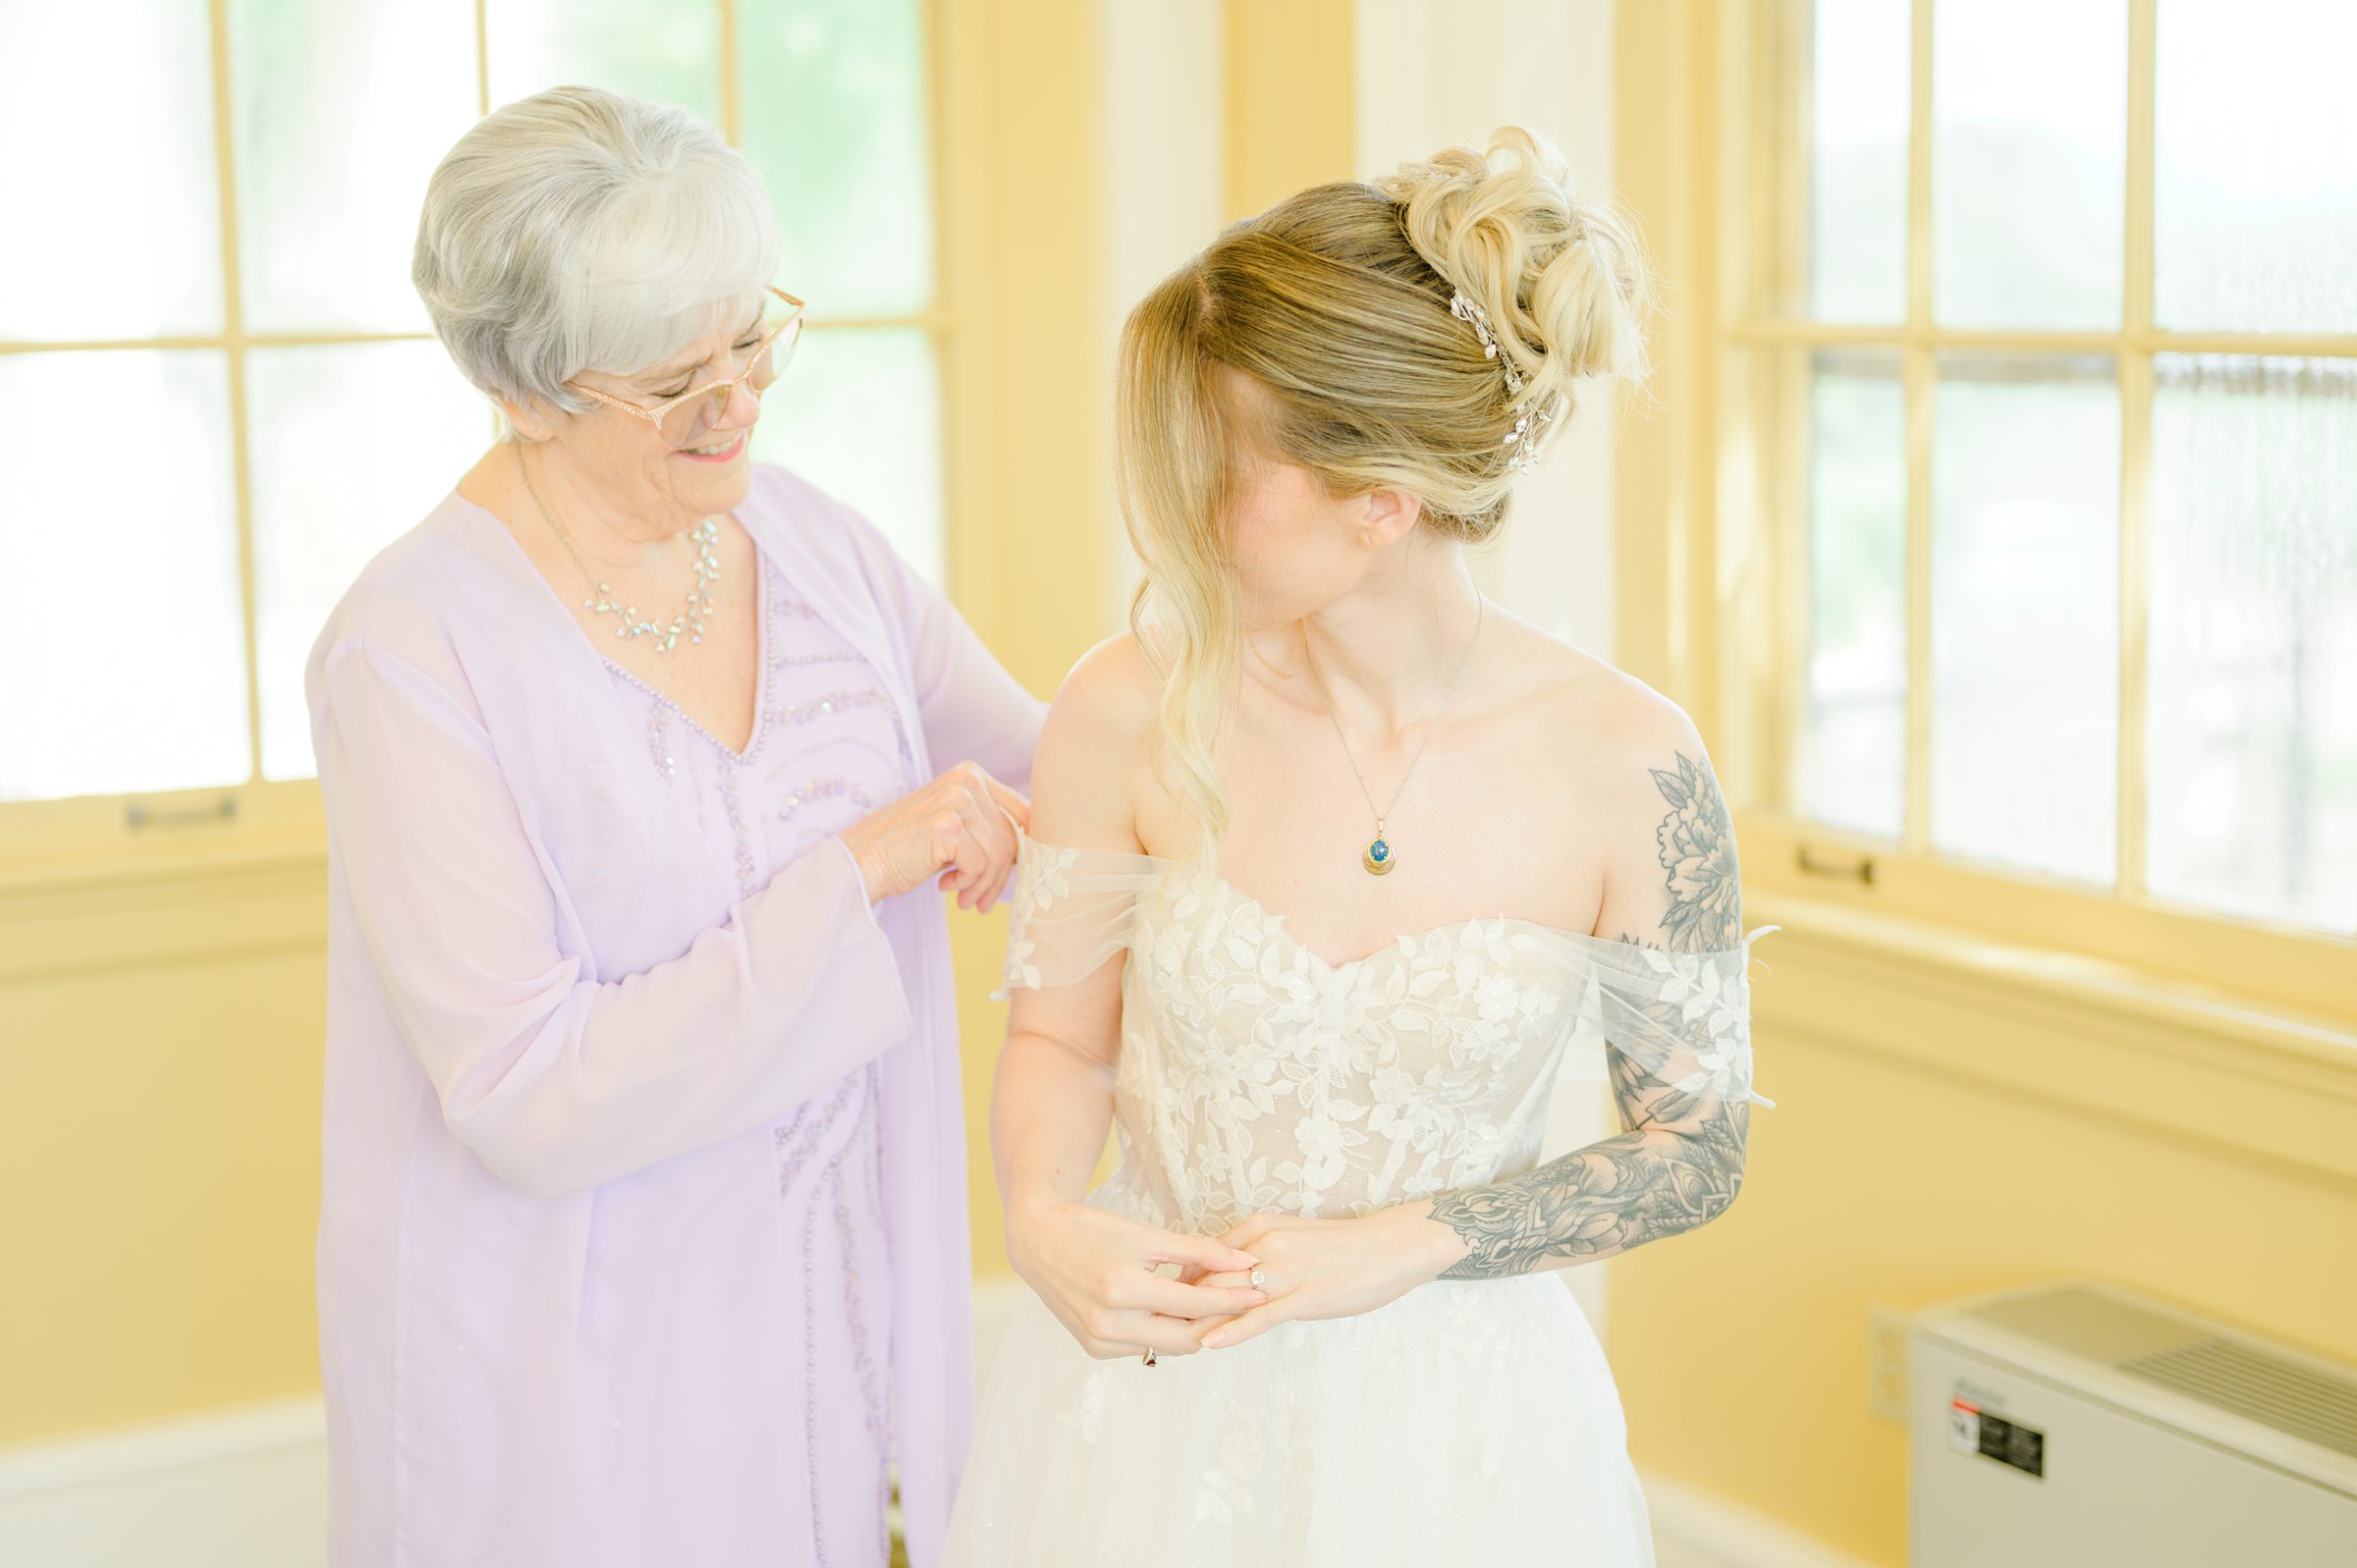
0, 0, 222, 337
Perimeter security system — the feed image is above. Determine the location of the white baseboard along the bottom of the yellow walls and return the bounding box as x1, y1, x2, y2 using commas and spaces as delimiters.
0, 1280, 1869, 1568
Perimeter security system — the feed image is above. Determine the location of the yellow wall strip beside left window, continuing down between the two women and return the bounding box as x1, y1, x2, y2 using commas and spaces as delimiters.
941, 0, 1113, 1275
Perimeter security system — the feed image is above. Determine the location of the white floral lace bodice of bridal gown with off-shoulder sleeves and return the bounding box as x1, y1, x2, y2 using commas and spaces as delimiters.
1007, 839, 1758, 1235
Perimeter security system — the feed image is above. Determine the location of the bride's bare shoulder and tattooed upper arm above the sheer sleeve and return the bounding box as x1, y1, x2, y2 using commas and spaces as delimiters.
1480, 622, 1742, 952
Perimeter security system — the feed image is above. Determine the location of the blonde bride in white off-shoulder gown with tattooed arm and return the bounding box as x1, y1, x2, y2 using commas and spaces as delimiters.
948, 128, 1766, 1568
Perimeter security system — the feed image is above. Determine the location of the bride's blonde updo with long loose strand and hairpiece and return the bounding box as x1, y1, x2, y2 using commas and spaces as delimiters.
1115, 125, 1652, 853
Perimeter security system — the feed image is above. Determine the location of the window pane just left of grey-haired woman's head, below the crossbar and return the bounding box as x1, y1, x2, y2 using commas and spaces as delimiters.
246, 342, 490, 778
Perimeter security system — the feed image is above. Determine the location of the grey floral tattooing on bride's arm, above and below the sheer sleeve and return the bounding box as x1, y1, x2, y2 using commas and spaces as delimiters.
1431, 722, 1749, 1280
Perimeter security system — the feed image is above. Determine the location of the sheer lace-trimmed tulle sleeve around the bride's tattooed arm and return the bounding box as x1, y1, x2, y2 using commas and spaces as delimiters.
1562, 927, 1778, 1122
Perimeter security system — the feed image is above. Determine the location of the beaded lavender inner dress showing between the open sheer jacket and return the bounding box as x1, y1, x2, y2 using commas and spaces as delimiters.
608, 547, 917, 1568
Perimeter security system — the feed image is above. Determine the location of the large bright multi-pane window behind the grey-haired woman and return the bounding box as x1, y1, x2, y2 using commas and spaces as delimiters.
0, 0, 945, 820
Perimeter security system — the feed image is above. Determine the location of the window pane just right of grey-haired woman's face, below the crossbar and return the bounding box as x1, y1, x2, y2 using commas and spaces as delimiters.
752, 328, 943, 587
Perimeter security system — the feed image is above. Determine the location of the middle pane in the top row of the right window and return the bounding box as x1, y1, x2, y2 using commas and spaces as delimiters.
1931, 0, 2128, 328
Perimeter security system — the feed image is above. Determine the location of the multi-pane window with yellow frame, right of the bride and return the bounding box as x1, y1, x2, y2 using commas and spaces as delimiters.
1721, 0, 2357, 986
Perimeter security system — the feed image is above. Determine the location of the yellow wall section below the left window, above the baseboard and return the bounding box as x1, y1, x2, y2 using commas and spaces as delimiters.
0, 886, 325, 1445
